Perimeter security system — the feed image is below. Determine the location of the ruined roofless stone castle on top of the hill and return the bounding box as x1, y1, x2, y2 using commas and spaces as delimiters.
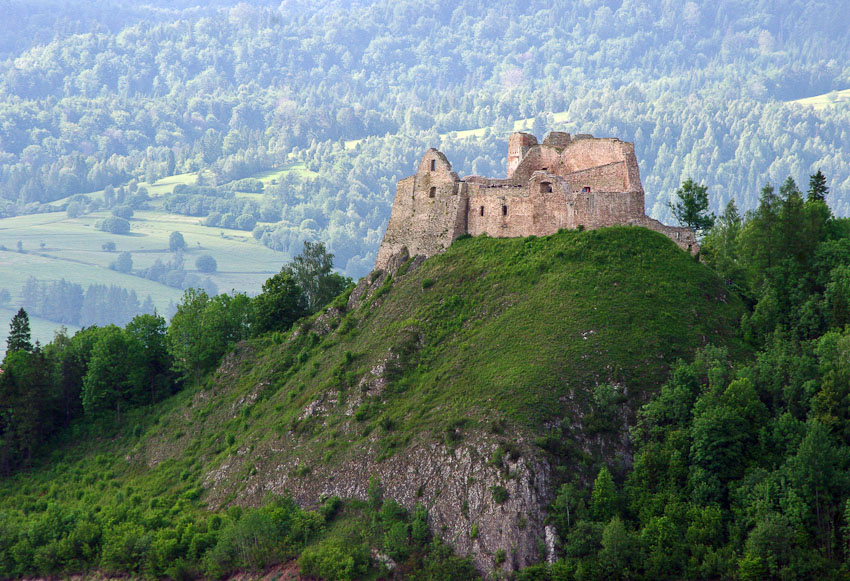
375, 131, 699, 269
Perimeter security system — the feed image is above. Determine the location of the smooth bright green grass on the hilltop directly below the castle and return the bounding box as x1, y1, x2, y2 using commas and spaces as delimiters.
232, 227, 742, 448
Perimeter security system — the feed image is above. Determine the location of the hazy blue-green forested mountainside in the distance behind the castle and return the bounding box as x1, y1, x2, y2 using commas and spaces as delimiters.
0, 0, 850, 275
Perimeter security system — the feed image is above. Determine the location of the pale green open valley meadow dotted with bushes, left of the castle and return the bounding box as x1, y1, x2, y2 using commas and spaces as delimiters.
0, 172, 308, 352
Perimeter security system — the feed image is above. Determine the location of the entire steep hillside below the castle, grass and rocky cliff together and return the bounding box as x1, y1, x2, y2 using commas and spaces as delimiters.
0, 227, 743, 570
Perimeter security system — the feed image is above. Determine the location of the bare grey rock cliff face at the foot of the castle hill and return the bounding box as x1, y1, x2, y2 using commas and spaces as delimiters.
227, 432, 552, 572
